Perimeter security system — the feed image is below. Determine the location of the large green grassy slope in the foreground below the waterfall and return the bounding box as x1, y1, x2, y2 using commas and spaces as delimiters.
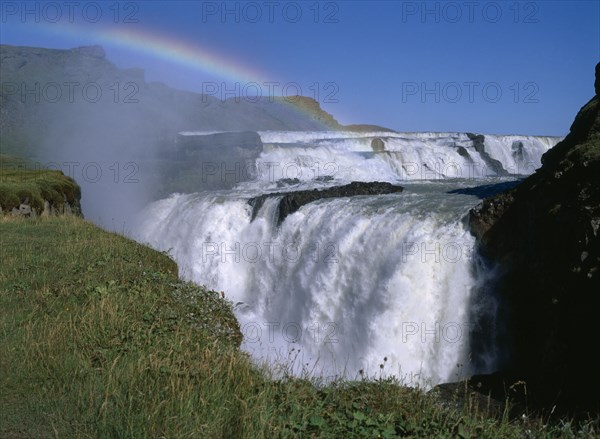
0, 216, 597, 439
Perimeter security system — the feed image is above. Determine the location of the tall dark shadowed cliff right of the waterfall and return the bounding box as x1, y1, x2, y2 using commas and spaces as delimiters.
469, 64, 600, 410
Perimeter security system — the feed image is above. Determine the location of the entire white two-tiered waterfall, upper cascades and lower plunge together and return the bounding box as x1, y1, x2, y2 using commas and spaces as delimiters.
134, 132, 559, 385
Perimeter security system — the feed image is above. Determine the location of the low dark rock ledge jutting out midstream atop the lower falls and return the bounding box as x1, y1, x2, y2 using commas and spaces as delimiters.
248, 181, 404, 224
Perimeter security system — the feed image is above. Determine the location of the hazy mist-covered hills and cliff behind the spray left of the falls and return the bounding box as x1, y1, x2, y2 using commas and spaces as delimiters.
0, 45, 360, 228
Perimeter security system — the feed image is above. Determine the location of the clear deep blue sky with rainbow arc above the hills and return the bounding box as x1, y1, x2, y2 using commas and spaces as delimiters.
0, 0, 600, 135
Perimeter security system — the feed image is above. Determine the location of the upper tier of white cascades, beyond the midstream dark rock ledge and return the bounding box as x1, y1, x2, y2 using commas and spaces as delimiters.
240, 131, 560, 188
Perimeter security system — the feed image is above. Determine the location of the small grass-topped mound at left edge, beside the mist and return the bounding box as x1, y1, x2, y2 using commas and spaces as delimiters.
0, 154, 81, 213
